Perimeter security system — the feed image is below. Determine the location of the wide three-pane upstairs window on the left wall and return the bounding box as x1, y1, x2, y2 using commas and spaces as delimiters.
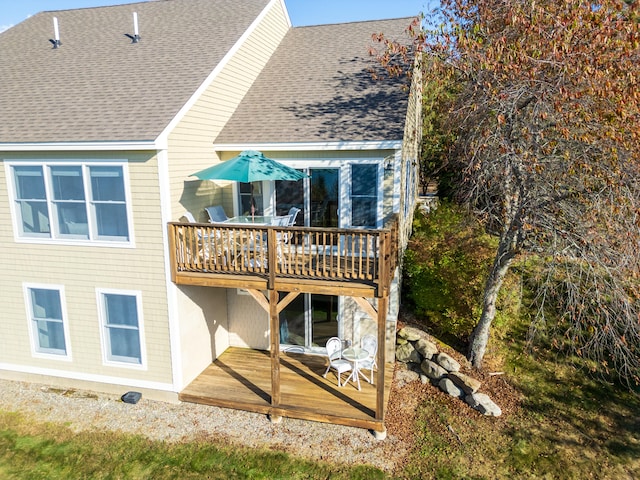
11, 164, 130, 242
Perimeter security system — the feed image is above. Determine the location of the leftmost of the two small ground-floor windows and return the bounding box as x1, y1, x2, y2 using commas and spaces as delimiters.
25, 285, 69, 357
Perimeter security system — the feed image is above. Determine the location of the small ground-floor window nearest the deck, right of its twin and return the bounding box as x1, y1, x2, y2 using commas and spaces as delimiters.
98, 290, 144, 365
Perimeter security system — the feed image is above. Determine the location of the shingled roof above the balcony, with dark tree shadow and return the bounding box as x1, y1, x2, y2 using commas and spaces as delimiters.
215, 18, 412, 145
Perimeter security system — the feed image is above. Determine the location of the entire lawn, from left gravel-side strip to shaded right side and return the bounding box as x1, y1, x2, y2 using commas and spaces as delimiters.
0, 329, 640, 480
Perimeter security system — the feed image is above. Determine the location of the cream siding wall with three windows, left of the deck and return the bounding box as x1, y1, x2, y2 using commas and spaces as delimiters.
0, 152, 172, 398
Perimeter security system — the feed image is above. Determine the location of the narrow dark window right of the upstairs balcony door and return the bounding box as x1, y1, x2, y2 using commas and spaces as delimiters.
351, 163, 378, 228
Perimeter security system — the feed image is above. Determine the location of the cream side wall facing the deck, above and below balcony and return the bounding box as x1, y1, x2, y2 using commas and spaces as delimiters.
167, 2, 289, 372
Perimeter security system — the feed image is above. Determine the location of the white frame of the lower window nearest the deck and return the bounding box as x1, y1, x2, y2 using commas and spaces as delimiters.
96, 288, 147, 370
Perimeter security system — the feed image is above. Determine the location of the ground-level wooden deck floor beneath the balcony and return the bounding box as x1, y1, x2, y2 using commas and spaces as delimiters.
179, 347, 393, 431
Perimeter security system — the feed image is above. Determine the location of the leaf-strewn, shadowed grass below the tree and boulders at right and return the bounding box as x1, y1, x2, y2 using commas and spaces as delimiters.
402, 312, 640, 480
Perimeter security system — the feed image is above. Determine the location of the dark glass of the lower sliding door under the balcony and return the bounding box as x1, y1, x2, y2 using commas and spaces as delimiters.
280, 293, 340, 349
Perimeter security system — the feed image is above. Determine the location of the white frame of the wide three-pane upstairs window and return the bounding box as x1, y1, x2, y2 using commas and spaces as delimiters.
5, 160, 135, 248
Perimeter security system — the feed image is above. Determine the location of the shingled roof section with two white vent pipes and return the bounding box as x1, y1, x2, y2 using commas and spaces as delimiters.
0, 0, 268, 143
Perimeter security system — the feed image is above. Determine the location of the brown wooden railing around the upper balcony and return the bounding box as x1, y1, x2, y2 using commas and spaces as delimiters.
169, 221, 397, 294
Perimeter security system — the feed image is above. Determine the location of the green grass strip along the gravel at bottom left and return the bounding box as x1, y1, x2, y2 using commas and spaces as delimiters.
0, 412, 384, 480
